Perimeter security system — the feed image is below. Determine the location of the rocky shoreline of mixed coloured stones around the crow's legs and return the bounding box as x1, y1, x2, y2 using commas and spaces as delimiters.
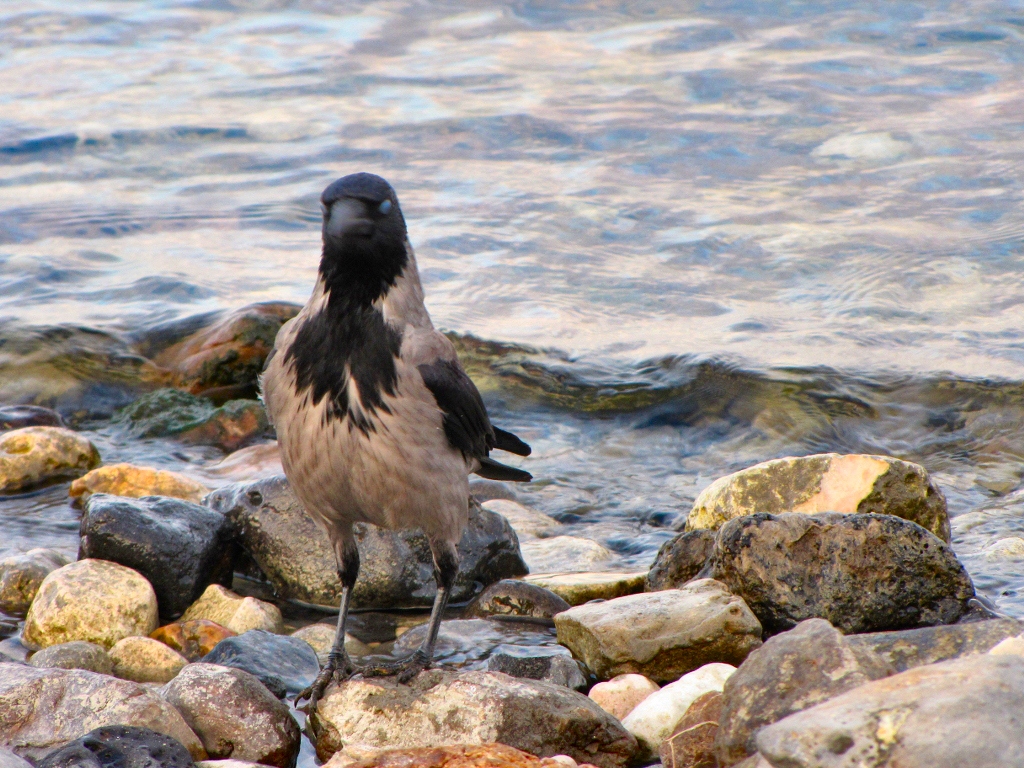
0, 304, 1024, 768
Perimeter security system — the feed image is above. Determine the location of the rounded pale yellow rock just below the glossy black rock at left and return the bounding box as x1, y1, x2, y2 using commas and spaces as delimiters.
22, 559, 157, 648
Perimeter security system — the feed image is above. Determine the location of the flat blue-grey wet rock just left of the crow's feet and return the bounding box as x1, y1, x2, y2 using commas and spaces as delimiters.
203, 630, 319, 698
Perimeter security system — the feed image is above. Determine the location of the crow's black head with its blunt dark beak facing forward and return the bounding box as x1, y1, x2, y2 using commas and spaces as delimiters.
321, 173, 409, 305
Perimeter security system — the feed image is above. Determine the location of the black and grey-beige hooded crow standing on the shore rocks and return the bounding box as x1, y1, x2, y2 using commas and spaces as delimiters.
260, 172, 532, 712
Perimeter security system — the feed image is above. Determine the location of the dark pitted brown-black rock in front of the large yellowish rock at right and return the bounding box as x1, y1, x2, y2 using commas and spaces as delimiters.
710, 513, 974, 634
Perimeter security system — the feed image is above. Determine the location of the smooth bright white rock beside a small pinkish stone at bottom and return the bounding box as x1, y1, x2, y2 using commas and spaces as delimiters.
623, 664, 736, 756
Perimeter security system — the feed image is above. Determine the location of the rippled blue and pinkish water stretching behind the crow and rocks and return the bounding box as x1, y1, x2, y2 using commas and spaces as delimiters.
0, 0, 1024, 614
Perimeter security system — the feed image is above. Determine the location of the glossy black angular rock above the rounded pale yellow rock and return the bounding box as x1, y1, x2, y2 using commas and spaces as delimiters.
78, 494, 233, 622
